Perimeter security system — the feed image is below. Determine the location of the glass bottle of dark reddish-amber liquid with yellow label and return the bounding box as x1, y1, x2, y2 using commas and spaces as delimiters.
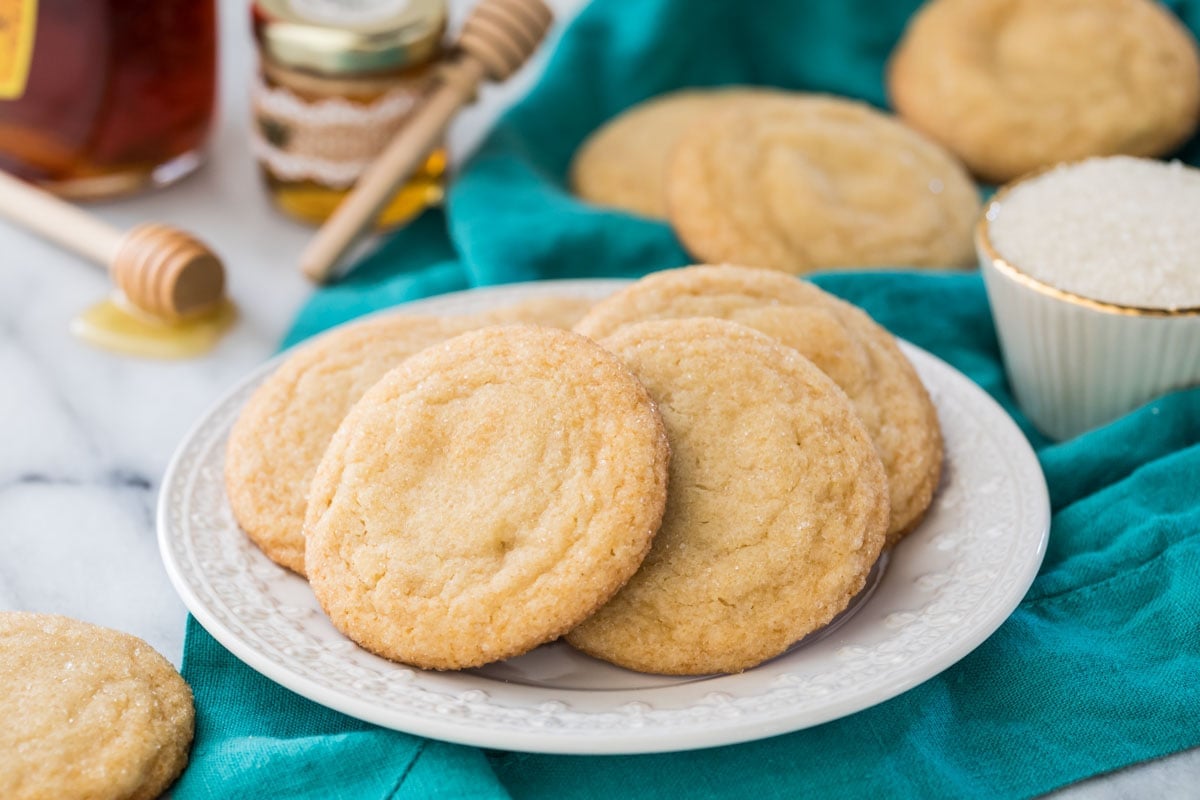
0, 0, 217, 198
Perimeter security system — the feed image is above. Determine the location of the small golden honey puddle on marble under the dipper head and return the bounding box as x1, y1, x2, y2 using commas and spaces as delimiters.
71, 293, 238, 359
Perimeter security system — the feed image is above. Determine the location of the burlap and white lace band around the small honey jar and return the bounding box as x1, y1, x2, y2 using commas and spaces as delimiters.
252, 80, 421, 188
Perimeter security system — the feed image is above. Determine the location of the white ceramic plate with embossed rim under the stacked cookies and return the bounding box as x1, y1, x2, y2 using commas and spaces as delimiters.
158, 281, 1050, 753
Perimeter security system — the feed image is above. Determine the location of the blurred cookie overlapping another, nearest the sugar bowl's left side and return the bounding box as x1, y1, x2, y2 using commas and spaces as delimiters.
666, 92, 979, 273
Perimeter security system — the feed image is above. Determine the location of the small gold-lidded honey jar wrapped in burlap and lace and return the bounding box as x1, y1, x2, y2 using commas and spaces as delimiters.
251, 0, 446, 227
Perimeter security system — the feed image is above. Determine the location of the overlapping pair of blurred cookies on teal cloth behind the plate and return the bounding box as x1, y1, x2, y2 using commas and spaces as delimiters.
571, 88, 979, 275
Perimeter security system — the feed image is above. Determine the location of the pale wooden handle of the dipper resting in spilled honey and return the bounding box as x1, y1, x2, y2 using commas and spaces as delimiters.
0, 172, 122, 266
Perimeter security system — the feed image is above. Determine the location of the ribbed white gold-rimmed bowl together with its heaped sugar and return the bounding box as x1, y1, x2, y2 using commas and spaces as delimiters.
976, 156, 1200, 439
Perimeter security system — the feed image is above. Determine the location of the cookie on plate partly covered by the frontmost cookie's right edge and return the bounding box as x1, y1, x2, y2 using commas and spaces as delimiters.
566, 319, 888, 675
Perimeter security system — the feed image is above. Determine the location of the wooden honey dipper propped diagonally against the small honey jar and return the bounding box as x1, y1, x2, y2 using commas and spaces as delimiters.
300, 0, 554, 283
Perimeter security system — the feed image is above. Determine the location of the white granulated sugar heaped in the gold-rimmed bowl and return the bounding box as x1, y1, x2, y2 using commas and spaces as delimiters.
988, 156, 1200, 308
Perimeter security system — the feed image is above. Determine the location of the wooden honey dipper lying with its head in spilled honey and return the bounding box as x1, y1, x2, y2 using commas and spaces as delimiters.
0, 173, 224, 323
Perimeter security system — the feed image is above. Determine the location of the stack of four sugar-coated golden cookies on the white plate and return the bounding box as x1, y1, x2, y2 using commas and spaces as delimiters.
227, 266, 942, 674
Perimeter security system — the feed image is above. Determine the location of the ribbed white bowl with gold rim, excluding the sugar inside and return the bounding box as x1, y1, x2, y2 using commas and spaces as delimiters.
976, 179, 1200, 439
